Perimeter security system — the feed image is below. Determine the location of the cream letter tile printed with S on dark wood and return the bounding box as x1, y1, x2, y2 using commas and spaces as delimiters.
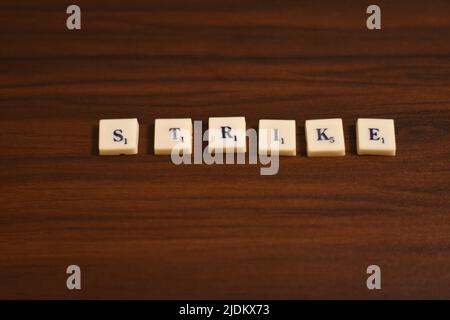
98, 119, 139, 155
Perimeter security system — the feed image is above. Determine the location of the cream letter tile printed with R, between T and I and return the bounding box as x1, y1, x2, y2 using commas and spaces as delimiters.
208, 117, 247, 153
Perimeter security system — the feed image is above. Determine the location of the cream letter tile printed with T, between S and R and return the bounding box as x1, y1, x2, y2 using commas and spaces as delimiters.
154, 119, 192, 155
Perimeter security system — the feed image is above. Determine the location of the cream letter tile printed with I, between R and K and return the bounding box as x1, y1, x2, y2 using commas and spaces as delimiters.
258, 120, 297, 156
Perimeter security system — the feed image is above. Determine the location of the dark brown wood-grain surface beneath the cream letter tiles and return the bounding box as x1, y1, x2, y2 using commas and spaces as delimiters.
0, 0, 450, 299
